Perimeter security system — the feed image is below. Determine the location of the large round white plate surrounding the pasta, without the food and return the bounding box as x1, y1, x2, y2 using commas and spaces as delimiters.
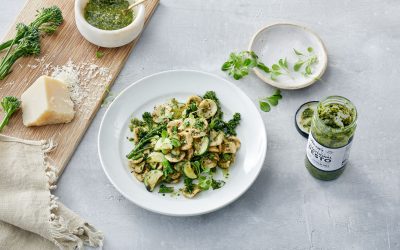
98, 70, 267, 216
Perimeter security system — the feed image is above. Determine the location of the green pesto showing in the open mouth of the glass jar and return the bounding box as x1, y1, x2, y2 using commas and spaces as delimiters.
318, 103, 354, 128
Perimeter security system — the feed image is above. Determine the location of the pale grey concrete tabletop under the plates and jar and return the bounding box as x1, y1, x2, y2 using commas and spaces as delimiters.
0, 0, 400, 249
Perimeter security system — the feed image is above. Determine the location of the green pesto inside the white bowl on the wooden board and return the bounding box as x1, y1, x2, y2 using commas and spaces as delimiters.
84, 0, 134, 30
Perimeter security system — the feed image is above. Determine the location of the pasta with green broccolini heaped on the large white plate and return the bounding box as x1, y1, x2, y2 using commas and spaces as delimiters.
126, 91, 241, 198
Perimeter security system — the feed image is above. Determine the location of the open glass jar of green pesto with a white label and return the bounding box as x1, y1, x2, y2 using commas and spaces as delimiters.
305, 96, 357, 180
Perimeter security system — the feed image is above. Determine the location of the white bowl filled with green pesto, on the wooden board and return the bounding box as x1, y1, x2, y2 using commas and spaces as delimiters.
75, 0, 145, 48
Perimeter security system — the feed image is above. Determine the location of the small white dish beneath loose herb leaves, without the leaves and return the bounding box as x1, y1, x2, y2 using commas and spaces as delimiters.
249, 23, 328, 89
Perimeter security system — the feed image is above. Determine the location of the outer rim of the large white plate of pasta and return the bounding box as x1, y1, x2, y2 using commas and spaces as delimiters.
97, 69, 268, 217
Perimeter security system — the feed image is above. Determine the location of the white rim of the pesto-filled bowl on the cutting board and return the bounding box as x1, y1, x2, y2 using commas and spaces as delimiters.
75, 0, 145, 35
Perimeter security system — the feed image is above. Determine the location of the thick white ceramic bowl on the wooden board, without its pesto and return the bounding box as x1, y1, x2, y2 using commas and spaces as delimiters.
75, 0, 145, 48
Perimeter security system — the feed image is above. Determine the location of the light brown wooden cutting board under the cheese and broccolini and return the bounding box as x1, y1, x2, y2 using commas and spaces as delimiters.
0, 0, 159, 175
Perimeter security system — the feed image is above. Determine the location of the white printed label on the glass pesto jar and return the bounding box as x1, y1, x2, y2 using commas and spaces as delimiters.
306, 133, 351, 171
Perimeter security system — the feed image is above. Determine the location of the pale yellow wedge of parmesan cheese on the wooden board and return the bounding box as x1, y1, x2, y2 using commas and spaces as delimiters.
21, 76, 75, 127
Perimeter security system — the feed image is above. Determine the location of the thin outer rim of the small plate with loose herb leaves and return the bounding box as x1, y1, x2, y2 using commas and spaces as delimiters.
248, 21, 328, 90
